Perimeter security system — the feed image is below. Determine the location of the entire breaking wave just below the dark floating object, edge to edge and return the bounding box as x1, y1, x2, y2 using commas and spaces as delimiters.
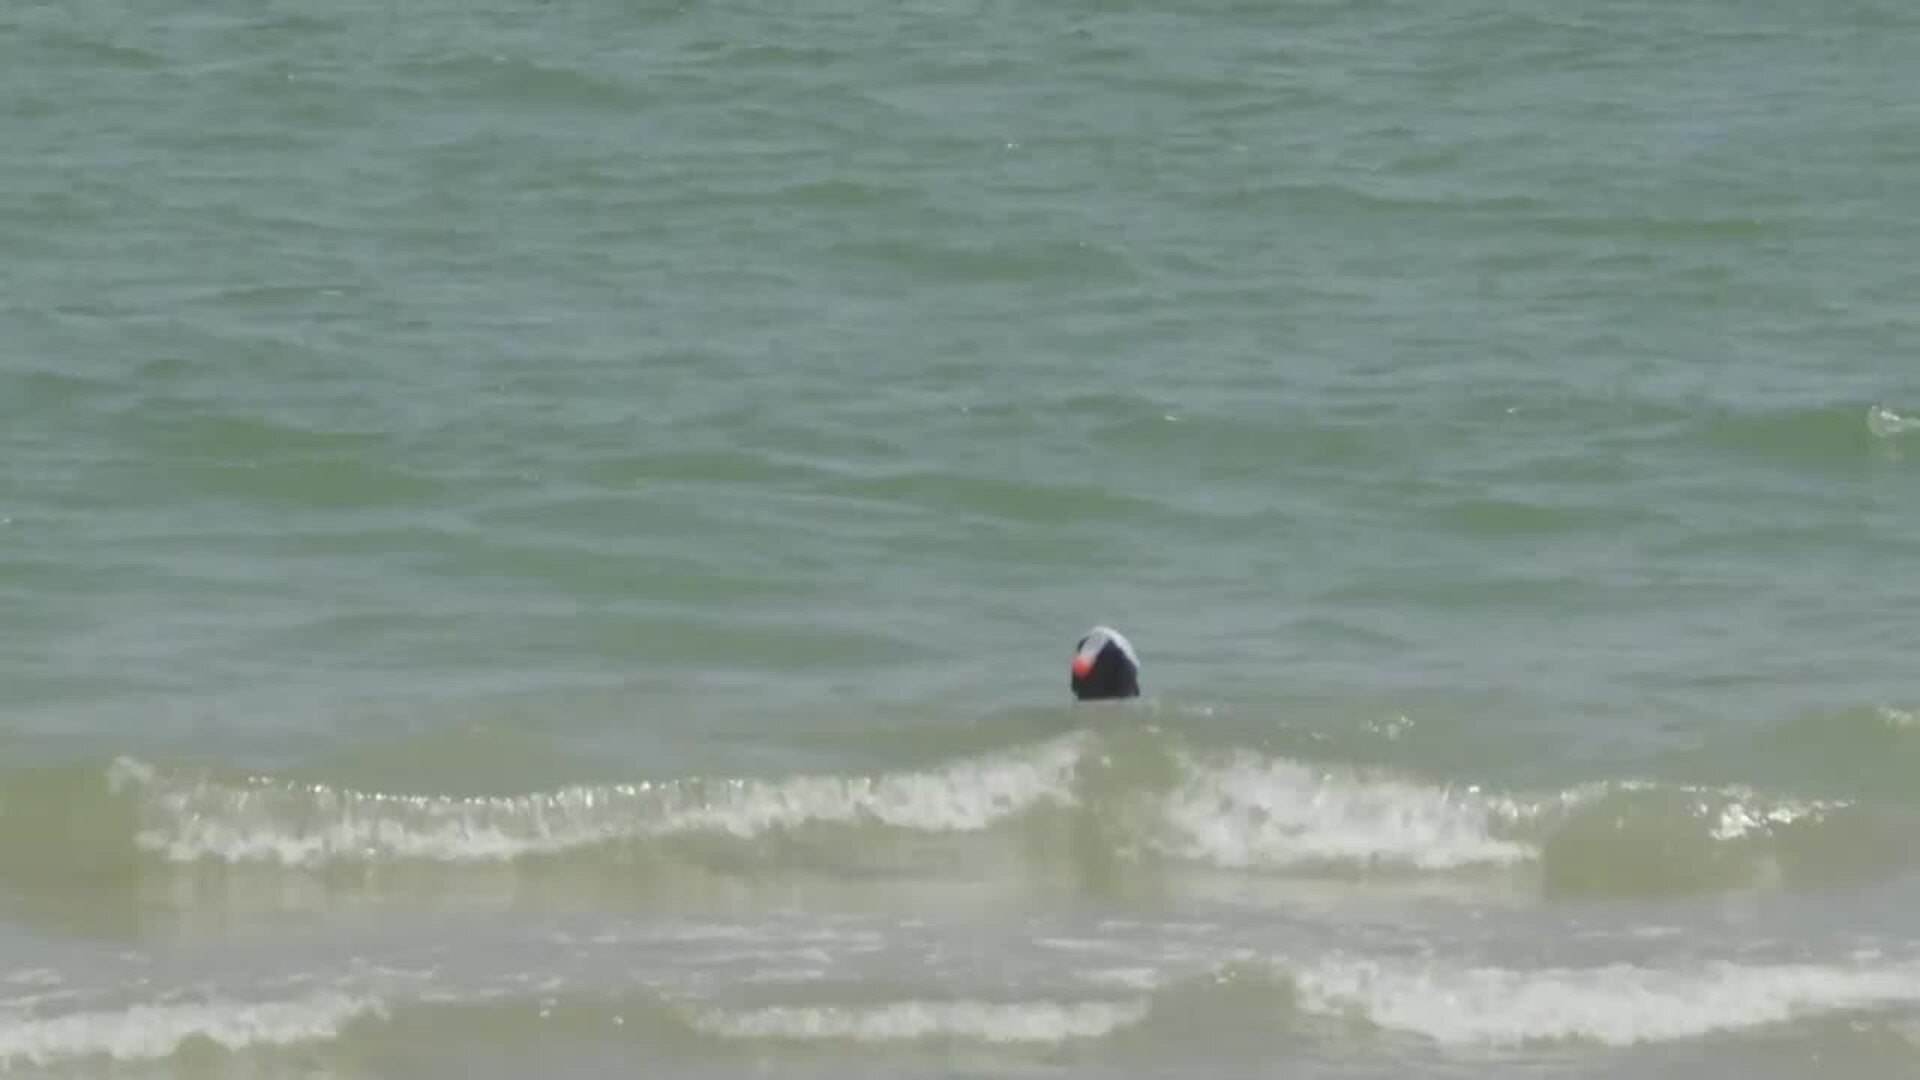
0, 721, 1914, 903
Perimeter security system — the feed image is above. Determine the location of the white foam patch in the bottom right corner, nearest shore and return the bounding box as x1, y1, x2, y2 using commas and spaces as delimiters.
1294, 961, 1920, 1045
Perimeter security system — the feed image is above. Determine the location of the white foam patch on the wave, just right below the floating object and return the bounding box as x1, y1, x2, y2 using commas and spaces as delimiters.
1160, 751, 1536, 871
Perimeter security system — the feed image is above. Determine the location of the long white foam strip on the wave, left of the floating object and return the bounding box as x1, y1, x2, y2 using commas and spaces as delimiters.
108, 736, 1083, 867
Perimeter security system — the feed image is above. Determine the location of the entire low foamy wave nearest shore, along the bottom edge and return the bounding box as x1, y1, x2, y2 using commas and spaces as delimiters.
0, 949, 1920, 1072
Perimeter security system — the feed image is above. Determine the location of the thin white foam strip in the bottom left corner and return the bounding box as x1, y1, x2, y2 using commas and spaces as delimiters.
0, 994, 384, 1068
